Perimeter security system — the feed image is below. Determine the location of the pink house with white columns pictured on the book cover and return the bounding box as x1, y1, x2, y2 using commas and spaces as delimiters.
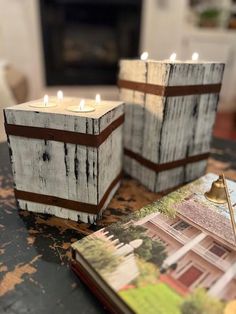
135, 209, 236, 300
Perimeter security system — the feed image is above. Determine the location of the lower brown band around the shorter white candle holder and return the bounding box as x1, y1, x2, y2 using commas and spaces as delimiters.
15, 173, 122, 214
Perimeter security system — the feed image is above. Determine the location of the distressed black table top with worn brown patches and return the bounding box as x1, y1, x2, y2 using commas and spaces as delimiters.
0, 140, 236, 314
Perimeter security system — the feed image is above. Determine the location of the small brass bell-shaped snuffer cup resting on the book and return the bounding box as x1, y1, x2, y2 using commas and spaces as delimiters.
205, 175, 227, 204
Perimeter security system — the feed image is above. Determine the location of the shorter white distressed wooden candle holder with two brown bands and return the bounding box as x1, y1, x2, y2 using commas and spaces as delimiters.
5, 99, 124, 222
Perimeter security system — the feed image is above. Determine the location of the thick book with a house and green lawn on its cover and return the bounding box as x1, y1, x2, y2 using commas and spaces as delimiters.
71, 174, 236, 314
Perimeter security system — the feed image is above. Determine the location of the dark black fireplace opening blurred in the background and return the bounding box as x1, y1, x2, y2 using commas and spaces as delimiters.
40, 0, 142, 86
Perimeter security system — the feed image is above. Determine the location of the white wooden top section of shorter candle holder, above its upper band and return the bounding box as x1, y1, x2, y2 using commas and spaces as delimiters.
6, 98, 123, 134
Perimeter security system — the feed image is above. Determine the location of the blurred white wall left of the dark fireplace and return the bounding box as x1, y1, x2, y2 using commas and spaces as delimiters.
0, 0, 43, 98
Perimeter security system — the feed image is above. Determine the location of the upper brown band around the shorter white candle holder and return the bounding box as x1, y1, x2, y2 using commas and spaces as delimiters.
5, 114, 124, 147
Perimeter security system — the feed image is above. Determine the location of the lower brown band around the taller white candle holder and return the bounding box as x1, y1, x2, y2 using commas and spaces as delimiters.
124, 148, 209, 172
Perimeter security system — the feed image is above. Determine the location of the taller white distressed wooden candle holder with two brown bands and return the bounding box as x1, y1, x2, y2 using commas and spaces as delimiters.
118, 60, 224, 192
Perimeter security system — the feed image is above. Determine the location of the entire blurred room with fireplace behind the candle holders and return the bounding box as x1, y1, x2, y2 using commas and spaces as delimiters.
0, 0, 236, 141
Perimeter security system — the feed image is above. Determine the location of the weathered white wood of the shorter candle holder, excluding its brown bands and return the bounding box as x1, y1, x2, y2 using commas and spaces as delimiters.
5, 100, 124, 222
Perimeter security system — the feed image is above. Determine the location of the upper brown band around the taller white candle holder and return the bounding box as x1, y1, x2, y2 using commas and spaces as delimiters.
118, 80, 221, 96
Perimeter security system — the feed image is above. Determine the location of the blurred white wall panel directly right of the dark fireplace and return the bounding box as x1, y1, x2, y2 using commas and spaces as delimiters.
141, 0, 187, 59
